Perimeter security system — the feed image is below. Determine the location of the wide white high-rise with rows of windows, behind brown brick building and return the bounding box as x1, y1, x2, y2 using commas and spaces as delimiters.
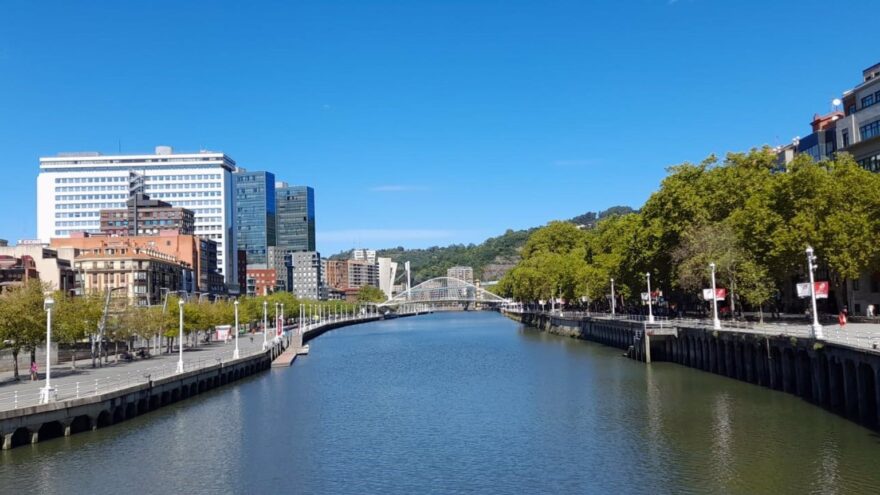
37, 146, 239, 293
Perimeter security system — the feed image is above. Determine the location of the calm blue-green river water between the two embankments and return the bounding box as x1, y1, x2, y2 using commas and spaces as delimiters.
0, 313, 880, 494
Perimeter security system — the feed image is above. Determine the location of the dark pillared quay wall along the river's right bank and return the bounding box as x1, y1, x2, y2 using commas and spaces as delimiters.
505, 312, 880, 431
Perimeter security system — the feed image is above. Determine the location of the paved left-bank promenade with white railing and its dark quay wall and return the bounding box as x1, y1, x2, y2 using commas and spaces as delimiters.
0, 314, 381, 450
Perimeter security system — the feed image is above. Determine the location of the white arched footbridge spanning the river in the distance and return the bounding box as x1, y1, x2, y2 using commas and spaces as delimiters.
378, 277, 510, 308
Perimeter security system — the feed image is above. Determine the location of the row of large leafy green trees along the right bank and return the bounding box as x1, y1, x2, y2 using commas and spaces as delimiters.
496, 148, 880, 318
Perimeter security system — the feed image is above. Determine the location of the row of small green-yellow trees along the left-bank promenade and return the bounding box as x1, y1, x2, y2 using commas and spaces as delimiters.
0, 279, 384, 379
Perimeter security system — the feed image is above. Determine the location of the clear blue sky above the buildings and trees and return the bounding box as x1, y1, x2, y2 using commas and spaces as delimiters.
0, 0, 880, 254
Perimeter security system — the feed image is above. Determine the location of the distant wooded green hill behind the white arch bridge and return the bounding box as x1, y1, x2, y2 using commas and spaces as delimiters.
331, 206, 635, 285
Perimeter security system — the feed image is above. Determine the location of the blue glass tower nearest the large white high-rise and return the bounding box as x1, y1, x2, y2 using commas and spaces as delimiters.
233, 169, 275, 268
